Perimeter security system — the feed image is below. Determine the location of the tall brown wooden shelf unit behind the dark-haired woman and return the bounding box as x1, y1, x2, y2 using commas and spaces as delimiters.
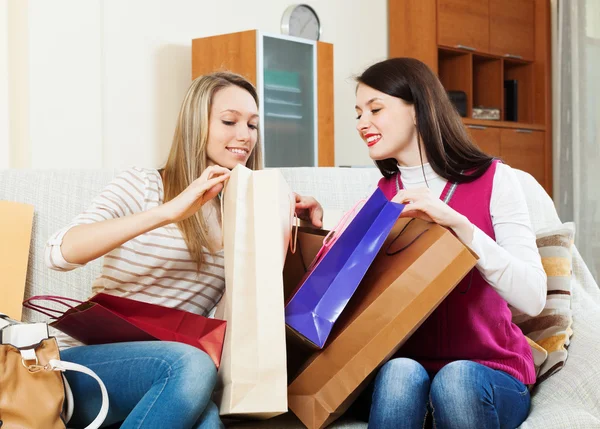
388, 0, 552, 195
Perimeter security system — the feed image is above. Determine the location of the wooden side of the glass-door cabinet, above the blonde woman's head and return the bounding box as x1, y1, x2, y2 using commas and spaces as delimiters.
192, 30, 257, 86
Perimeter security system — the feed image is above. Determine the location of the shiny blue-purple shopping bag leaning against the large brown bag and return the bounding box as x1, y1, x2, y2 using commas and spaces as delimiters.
285, 189, 404, 349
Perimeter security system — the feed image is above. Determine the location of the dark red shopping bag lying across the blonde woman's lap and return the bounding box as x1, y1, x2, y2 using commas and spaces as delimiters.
23, 293, 226, 368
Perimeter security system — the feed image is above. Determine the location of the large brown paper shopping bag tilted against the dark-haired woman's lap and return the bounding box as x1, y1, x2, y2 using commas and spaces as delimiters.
286, 218, 477, 429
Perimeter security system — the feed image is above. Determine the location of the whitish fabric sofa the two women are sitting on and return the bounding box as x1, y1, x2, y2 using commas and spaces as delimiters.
0, 168, 600, 429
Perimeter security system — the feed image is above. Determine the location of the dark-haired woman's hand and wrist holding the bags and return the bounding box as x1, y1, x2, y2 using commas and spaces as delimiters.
392, 188, 473, 244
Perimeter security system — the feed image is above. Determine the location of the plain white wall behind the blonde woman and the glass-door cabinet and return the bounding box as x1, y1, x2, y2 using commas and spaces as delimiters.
5, 0, 387, 168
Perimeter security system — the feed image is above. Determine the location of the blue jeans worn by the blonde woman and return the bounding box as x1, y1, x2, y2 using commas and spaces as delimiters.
61, 341, 224, 429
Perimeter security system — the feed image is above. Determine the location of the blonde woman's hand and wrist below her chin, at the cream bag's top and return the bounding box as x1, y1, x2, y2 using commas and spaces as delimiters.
162, 165, 231, 222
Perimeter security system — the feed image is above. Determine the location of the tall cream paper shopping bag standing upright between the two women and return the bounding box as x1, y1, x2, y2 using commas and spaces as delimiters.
215, 165, 294, 419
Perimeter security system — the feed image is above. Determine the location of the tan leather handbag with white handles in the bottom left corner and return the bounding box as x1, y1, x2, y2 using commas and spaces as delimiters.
0, 313, 108, 429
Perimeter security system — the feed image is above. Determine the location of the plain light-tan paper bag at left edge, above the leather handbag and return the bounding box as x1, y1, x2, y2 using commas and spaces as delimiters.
0, 201, 33, 320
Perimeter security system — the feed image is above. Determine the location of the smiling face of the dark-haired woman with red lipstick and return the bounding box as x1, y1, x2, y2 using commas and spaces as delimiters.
356, 83, 421, 166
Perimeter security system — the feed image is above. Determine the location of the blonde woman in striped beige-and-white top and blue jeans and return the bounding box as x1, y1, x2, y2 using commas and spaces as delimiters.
46, 73, 322, 429
